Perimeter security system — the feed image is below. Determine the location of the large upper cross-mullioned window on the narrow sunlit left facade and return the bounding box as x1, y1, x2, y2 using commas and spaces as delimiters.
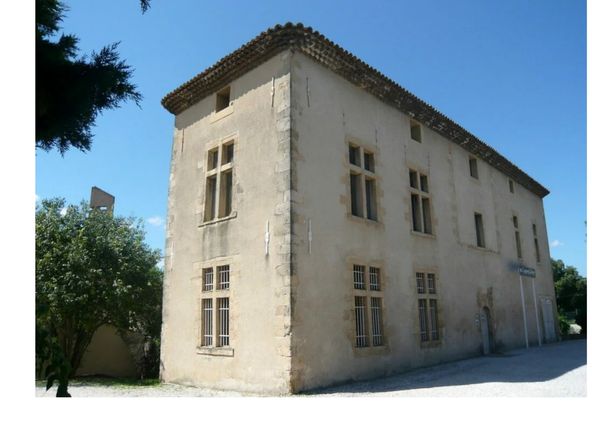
204, 140, 234, 222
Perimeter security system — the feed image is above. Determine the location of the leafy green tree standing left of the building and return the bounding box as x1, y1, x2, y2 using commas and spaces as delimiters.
35, 199, 162, 395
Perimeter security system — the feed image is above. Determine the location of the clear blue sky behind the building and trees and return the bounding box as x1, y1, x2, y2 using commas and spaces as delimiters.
35, 0, 587, 275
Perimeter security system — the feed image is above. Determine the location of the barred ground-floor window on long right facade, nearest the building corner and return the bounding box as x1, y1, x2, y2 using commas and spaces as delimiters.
353, 265, 384, 347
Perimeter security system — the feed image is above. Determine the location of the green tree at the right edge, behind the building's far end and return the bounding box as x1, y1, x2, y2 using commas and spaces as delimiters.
551, 259, 586, 333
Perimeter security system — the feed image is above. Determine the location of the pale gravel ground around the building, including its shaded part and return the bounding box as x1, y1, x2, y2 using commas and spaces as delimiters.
36, 340, 586, 397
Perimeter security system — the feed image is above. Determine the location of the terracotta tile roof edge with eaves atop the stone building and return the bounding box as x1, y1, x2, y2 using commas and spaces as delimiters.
162, 23, 549, 197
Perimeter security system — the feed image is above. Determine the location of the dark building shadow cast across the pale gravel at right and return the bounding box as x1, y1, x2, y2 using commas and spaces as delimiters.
302, 340, 586, 395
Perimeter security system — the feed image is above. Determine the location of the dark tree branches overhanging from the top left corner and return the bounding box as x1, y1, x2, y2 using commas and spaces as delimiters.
35, 0, 150, 154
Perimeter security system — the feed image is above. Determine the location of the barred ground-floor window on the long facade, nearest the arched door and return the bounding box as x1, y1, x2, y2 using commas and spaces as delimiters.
415, 272, 440, 343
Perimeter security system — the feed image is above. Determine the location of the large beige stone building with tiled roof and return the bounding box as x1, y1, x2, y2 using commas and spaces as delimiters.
161, 24, 557, 394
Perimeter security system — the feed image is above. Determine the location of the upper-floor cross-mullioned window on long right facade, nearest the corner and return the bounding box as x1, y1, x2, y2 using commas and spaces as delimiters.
348, 143, 378, 221
